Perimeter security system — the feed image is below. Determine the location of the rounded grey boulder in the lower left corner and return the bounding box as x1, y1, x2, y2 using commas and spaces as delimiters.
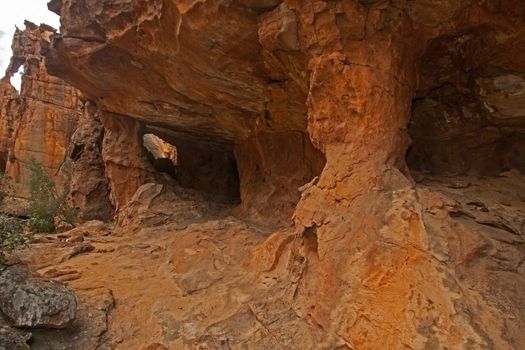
0, 265, 77, 328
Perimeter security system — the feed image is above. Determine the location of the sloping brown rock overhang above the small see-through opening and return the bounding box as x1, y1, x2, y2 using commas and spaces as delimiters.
47, 0, 272, 140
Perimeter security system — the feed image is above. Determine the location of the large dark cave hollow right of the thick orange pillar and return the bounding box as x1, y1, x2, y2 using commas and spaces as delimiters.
407, 32, 525, 176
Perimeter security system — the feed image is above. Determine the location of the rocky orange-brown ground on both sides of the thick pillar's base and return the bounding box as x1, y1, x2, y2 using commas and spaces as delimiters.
3, 172, 525, 349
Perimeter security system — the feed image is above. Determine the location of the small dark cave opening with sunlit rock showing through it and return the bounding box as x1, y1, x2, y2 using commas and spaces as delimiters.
143, 127, 240, 204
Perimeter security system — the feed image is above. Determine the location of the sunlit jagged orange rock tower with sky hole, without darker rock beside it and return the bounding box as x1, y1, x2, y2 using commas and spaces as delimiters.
2, 22, 81, 198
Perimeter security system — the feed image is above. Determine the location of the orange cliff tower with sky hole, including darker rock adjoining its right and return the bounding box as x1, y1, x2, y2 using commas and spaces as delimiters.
0, 22, 113, 220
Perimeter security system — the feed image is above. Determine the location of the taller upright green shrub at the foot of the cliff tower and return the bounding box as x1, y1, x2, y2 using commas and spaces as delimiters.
29, 158, 77, 233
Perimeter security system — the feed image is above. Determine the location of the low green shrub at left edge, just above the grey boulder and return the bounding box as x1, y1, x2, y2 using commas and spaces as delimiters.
0, 214, 29, 263
